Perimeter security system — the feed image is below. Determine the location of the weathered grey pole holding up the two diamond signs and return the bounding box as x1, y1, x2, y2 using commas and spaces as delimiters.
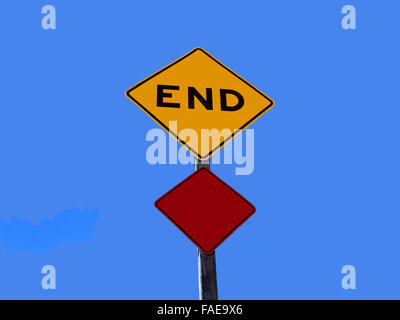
194, 158, 218, 300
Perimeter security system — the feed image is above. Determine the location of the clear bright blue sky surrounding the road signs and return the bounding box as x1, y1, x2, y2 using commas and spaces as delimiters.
0, 0, 400, 299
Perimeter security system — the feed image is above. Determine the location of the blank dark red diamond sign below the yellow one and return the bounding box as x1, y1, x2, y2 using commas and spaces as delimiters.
155, 168, 256, 254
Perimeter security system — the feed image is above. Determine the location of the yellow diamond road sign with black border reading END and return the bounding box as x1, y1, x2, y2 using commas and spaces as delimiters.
126, 48, 274, 160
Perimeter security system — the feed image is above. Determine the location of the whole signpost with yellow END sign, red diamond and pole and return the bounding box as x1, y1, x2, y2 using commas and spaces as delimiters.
126, 48, 274, 300
